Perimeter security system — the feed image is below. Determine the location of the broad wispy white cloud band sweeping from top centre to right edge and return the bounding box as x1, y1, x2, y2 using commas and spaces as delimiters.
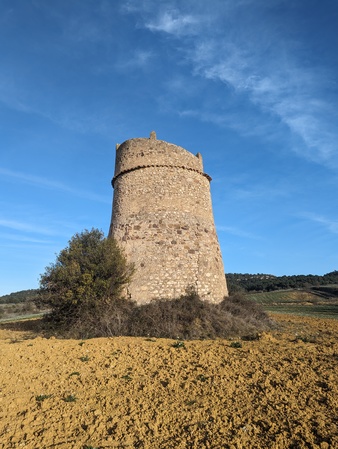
137, 0, 338, 168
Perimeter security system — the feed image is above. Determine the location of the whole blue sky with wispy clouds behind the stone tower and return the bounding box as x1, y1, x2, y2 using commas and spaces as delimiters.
0, 0, 338, 295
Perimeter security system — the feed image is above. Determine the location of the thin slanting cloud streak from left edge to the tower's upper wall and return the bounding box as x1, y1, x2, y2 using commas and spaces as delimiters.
0, 167, 111, 204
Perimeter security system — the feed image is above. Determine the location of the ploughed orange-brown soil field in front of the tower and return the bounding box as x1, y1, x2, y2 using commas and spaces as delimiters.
0, 316, 338, 449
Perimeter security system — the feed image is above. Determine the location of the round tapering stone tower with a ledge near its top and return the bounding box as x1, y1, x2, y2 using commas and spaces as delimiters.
109, 132, 228, 304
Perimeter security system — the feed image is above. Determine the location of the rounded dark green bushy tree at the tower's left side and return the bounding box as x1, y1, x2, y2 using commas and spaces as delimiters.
36, 229, 133, 333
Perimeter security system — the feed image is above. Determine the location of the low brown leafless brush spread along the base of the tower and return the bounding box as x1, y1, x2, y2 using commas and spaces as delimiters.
54, 292, 271, 339
